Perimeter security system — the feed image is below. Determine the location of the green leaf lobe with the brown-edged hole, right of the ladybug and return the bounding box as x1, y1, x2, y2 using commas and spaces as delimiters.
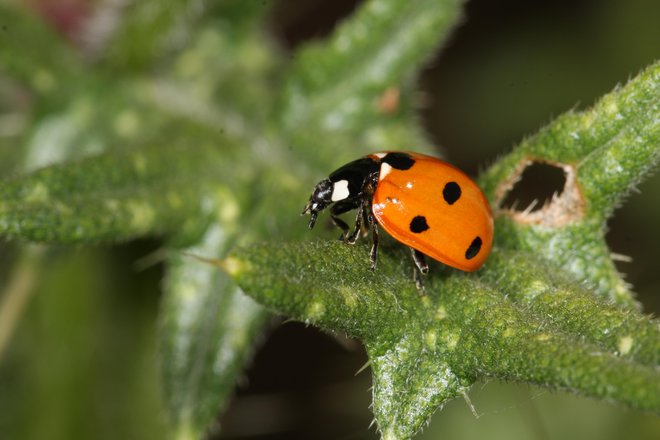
480, 64, 660, 306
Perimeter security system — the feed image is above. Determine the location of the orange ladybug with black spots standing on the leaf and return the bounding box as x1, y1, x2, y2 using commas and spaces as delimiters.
301, 151, 493, 288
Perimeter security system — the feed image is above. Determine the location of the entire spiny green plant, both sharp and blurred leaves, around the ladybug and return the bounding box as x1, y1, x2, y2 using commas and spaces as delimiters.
0, 0, 660, 439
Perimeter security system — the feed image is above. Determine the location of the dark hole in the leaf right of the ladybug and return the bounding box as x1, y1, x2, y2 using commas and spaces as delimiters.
501, 162, 566, 212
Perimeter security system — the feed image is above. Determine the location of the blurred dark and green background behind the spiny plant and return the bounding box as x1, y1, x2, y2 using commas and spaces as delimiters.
0, 0, 660, 440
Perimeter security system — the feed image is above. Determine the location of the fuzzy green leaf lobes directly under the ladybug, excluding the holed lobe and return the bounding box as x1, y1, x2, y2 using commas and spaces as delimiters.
226, 242, 660, 438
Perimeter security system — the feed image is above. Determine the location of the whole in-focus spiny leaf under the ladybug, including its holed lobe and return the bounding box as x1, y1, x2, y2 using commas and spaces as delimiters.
226, 63, 660, 439
